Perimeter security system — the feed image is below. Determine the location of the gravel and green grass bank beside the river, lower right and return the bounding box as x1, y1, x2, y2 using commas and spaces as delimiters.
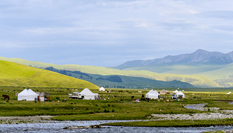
103, 110, 233, 127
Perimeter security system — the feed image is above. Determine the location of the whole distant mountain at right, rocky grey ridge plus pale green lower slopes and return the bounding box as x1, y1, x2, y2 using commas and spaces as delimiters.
115, 49, 233, 87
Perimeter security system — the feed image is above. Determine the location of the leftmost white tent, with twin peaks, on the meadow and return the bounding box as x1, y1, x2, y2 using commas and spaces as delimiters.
18, 89, 38, 101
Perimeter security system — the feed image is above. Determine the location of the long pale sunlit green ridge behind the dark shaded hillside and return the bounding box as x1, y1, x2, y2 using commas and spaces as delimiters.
0, 57, 219, 87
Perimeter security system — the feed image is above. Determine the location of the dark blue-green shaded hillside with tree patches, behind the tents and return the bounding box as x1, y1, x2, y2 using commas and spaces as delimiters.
45, 67, 195, 89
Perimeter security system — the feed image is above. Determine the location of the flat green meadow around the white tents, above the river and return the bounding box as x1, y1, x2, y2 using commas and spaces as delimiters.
0, 87, 233, 123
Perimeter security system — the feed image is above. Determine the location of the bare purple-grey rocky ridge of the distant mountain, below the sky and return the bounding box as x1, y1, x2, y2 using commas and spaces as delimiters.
115, 49, 233, 69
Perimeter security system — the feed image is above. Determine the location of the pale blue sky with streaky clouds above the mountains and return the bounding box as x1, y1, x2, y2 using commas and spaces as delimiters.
0, 0, 233, 67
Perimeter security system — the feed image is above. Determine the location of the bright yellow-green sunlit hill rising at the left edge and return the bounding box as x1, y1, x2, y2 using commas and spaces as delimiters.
0, 60, 98, 89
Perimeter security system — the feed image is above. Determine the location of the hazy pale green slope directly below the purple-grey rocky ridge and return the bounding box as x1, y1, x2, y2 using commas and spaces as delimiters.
118, 64, 233, 87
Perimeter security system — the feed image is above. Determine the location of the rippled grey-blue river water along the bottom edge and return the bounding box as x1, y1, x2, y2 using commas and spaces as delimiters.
0, 121, 233, 133
